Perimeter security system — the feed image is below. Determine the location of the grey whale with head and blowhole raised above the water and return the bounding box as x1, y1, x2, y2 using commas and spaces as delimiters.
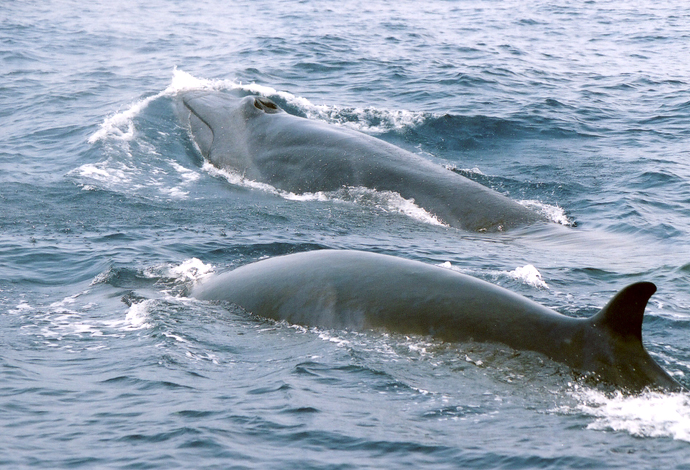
175, 90, 547, 232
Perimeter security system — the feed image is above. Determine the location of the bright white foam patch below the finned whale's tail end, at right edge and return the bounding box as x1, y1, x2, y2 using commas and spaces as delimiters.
573, 389, 690, 442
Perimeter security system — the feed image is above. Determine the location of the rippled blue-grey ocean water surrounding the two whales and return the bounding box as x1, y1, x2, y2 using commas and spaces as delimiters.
0, 0, 690, 469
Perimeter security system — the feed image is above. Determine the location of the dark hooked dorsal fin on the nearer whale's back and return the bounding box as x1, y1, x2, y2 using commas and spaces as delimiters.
591, 282, 656, 341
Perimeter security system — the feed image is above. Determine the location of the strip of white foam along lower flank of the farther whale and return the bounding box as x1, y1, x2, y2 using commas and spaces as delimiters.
202, 162, 447, 226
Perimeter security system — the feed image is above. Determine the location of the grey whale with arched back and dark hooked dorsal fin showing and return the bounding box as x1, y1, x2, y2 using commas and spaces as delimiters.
190, 250, 684, 393
